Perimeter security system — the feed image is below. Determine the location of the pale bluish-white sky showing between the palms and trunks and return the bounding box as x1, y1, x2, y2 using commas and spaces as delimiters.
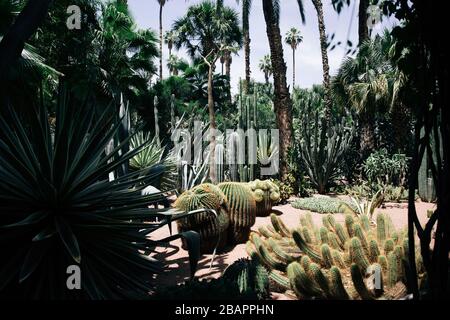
128, 0, 394, 92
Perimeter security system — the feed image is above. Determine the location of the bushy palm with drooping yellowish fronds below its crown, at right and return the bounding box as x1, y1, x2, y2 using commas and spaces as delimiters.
333, 31, 409, 155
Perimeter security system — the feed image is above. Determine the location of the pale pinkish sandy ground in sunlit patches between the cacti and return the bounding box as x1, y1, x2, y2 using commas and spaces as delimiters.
151, 195, 435, 287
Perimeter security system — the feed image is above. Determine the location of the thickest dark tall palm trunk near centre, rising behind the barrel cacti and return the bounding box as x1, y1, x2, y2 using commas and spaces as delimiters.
263, 0, 292, 181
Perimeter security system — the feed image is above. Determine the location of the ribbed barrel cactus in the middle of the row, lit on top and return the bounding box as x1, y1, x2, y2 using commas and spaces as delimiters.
218, 182, 256, 244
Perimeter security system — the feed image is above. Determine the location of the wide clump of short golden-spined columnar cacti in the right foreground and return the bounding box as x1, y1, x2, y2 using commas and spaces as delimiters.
247, 213, 424, 300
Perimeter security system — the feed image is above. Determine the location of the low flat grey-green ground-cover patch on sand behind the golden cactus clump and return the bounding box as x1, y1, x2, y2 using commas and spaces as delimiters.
292, 196, 356, 213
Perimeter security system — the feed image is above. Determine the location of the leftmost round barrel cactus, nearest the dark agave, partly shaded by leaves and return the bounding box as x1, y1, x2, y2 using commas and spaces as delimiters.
175, 184, 230, 253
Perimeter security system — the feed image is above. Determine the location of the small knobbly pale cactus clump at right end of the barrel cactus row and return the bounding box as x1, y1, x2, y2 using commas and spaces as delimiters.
248, 179, 280, 217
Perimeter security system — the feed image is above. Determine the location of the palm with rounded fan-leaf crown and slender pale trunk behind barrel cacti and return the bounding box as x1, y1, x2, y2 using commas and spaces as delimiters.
172, 0, 242, 182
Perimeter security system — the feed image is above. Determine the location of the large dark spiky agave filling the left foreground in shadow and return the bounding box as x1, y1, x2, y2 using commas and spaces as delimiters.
0, 90, 199, 299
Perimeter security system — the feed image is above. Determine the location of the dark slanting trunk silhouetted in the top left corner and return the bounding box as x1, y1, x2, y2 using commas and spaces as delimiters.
0, 0, 52, 77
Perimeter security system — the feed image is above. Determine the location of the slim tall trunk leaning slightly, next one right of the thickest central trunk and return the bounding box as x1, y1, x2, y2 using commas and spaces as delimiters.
312, 0, 333, 123
